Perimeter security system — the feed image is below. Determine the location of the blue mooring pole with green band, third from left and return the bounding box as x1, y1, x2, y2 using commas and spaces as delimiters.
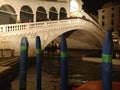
60, 35, 68, 90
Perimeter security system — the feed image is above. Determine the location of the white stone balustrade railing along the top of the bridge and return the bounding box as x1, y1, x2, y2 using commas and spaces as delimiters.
0, 19, 101, 32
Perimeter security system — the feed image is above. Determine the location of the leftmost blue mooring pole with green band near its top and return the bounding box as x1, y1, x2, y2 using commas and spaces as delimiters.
19, 37, 28, 90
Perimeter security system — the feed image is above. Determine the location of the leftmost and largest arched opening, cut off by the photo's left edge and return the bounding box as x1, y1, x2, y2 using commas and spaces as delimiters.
0, 4, 17, 24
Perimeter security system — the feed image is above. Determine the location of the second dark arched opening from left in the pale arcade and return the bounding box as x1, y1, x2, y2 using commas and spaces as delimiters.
20, 5, 34, 22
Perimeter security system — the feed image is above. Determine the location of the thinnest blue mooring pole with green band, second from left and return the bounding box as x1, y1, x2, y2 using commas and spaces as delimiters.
36, 36, 42, 90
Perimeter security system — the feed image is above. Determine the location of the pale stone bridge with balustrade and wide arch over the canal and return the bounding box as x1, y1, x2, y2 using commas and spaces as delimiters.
0, 18, 104, 56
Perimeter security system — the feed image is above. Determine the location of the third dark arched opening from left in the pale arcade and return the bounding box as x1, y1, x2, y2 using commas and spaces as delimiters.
36, 7, 47, 22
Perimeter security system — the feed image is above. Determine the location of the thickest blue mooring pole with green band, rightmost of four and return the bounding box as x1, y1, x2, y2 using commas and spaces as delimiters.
102, 30, 113, 90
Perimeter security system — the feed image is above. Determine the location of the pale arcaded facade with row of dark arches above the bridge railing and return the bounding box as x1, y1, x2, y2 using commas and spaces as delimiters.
0, 0, 82, 24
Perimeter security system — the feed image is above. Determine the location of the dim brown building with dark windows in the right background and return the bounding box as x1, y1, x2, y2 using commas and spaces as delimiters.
98, 2, 120, 49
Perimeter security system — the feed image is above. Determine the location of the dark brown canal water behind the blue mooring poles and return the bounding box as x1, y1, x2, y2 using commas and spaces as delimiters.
11, 50, 120, 90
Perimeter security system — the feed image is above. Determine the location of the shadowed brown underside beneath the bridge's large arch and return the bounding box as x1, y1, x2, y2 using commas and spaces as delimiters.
57, 30, 102, 49
